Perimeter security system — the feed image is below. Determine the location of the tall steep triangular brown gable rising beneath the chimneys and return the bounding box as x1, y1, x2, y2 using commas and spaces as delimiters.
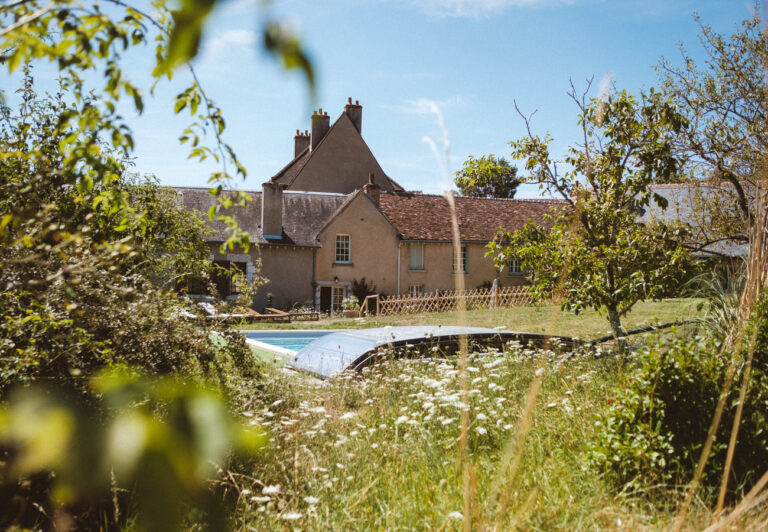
270, 112, 404, 193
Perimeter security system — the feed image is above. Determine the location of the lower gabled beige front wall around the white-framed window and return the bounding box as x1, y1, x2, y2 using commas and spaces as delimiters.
315, 194, 399, 302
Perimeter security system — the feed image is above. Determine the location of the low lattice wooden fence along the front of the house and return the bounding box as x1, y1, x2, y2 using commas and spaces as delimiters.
360, 286, 533, 316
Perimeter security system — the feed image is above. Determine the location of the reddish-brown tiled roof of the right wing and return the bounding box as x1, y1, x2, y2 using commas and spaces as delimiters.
380, 194, 568, 242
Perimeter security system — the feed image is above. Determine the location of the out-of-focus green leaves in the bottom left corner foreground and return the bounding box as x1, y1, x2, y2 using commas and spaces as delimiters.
0, 373, 265, 530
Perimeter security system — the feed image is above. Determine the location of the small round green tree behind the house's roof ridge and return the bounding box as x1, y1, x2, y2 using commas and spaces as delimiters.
453, 155, 520, 198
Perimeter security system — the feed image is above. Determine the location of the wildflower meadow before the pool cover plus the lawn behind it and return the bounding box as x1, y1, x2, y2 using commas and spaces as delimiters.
225, 300, 768, 530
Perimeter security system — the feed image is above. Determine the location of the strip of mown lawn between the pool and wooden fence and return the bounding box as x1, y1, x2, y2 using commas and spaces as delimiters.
242, 299, 700, 339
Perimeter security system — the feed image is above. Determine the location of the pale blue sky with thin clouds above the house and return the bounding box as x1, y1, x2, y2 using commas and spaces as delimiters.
3, 0, 753, 197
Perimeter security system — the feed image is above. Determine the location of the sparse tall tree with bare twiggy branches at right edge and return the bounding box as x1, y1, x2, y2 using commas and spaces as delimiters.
657, 4, 768, 247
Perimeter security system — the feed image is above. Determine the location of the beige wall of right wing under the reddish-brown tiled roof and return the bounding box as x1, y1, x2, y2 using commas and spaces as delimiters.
400, 242, 526, 293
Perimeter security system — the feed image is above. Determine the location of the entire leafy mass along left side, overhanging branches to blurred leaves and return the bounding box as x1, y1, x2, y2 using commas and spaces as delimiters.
0, 0, 314, 530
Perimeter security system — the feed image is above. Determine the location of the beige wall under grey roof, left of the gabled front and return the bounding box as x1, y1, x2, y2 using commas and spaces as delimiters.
212, 244, 313, 311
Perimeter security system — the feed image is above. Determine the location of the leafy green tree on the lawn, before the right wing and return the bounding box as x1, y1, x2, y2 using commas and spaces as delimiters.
488, 82, 689, 337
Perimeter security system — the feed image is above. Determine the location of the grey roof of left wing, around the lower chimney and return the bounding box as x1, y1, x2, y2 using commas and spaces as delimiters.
174, 187, 347, 247
